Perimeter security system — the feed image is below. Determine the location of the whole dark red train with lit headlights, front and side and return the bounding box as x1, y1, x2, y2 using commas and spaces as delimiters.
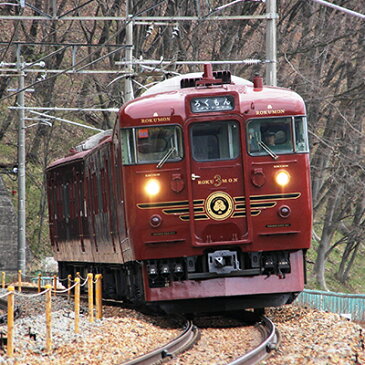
46, 65, 312, 312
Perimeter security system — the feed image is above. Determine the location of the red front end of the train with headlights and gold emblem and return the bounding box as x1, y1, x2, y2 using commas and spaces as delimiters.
118, 68, 312, 312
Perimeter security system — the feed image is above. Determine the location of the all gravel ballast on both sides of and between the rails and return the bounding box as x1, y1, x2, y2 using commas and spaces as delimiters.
0, 290, 365, 365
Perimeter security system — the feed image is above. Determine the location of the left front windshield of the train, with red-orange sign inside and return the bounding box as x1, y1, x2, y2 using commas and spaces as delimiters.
121, 125, 184, 166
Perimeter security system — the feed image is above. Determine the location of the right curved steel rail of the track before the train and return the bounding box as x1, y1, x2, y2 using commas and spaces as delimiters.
228, 316, 280, 365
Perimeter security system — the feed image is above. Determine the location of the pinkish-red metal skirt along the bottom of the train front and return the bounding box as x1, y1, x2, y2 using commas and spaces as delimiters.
145, 251, 304, 312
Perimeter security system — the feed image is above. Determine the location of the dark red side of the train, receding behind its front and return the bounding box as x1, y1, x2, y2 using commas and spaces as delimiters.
47, 136, 128, 266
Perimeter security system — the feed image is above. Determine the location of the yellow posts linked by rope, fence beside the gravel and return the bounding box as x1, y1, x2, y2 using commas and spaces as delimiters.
0, 270, 103, 357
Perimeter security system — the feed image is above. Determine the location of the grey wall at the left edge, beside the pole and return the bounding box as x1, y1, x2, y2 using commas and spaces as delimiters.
0, 176, 18, 272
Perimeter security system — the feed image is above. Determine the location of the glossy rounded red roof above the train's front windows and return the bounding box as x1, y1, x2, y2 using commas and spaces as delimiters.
119, 70, 306, 127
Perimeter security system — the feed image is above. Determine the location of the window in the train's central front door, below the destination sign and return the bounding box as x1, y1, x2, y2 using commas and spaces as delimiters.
190, 121, 240, 161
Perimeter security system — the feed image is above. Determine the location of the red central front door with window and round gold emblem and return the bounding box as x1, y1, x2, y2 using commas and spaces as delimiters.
188, 119, 248, 245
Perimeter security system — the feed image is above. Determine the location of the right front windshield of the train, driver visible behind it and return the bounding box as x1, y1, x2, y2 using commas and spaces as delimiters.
247, 117, 309, 156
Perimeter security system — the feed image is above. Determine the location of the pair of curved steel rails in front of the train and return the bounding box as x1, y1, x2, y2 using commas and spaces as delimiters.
123, 316, 280, 365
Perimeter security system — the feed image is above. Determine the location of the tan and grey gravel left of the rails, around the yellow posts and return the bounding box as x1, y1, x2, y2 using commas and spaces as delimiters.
0, 290, 182, 365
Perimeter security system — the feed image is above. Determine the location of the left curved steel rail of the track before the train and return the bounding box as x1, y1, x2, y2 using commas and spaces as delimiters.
122, 321, 199, 365
